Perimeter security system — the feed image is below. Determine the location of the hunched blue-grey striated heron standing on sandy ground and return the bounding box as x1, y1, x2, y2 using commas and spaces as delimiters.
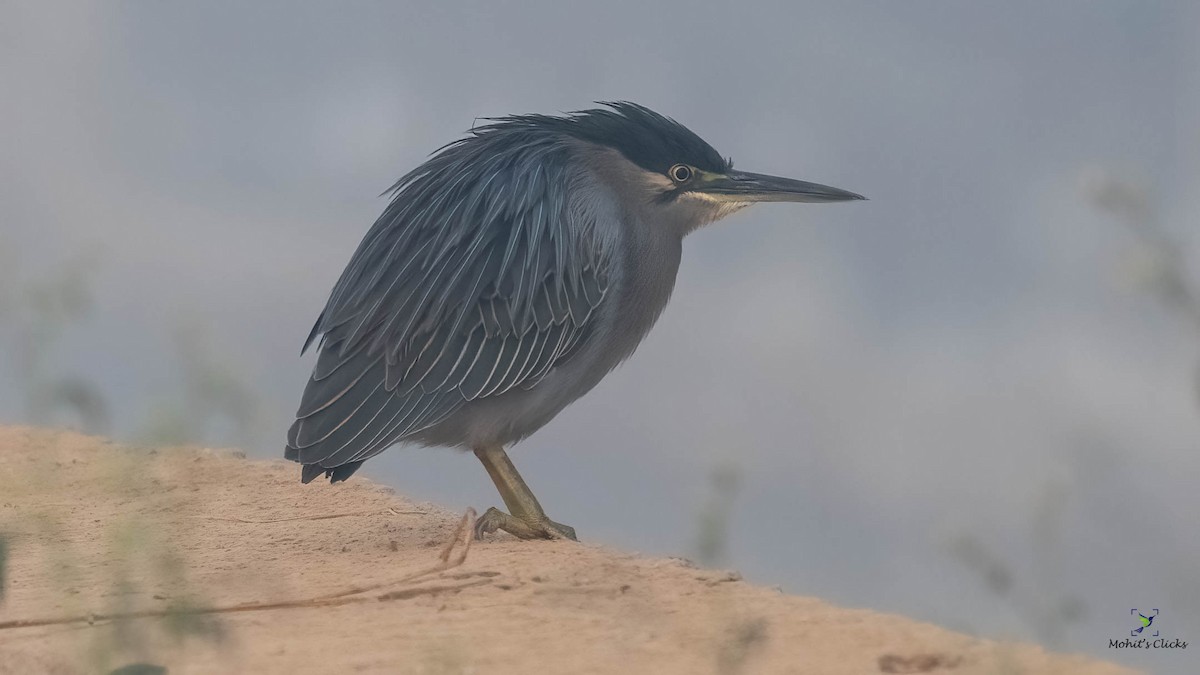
286, 102, 863, 539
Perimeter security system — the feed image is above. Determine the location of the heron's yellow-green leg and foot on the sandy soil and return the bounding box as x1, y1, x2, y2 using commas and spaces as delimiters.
475, 448, 578, 542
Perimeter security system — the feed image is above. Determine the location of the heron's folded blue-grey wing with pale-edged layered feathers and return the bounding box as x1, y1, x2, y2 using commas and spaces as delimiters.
287, 127, 611, 479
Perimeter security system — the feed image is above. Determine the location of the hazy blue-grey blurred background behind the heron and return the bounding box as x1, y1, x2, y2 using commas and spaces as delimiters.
0, 1, 1200, 669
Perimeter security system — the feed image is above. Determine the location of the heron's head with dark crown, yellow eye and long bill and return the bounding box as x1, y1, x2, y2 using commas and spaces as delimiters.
544, 102, 864, 232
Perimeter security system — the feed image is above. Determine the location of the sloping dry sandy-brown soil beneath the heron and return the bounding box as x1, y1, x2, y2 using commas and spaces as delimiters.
0, 428, 1126, 675
